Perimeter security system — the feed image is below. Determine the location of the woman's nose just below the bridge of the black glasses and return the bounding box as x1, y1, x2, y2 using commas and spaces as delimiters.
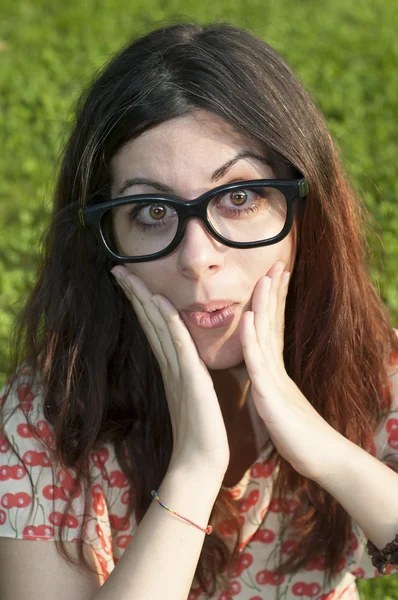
178, 218, 228, 279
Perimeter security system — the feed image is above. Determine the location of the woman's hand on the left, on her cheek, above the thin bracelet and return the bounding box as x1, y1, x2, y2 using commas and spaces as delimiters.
111, 265, 230, 477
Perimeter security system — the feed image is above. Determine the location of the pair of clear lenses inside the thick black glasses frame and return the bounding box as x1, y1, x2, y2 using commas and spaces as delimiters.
101, 187, 287, 257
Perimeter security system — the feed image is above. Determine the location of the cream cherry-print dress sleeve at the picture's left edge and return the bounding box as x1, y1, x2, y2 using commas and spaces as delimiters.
0, 376, 84, 541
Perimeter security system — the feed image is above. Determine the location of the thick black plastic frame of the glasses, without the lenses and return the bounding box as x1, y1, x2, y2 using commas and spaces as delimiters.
79, 178, 308, 263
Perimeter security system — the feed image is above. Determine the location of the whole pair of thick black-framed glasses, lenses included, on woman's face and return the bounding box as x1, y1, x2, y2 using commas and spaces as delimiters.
79, 179, 308, 263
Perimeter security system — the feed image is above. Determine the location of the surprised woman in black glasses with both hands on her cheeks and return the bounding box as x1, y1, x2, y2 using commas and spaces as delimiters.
0, 24, 398, 600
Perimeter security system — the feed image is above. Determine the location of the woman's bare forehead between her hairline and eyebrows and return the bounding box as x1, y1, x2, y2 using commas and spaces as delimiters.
111, 111, 274, 195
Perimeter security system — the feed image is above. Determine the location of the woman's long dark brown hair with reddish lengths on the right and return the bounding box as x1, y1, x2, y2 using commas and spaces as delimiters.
1, 19, 398, 595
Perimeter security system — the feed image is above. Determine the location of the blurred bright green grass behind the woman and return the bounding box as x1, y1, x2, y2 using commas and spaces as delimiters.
0, 0, 398, 600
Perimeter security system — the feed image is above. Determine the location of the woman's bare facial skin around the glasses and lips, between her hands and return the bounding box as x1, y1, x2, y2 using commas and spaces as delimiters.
112, 111, 295, 369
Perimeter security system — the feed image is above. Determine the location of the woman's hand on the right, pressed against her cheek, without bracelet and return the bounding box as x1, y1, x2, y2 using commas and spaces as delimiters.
239, 261, 345, 483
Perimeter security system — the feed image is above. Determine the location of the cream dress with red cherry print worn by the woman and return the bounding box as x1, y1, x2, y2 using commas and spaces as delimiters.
0, 340, 398, 600
